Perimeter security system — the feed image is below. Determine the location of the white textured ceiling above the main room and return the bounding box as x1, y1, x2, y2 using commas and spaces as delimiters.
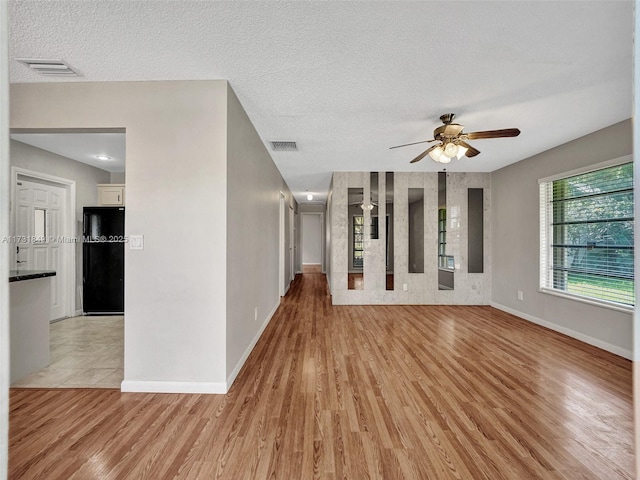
9, 0, 634, 203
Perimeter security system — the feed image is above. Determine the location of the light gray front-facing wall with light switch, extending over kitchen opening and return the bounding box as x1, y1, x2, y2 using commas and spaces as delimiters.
10, 81, 230, 393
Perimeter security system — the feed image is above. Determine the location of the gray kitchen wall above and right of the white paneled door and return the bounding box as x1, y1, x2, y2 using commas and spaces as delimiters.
9, 140, 111, 311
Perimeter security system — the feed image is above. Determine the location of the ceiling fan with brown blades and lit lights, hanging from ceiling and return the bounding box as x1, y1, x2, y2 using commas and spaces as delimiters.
390, 113, 520, 163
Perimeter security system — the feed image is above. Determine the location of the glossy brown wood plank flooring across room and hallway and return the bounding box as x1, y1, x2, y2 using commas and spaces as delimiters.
9, 274, 634, 480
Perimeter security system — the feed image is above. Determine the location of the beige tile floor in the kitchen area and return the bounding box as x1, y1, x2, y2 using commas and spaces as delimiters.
11, 315, 124, 388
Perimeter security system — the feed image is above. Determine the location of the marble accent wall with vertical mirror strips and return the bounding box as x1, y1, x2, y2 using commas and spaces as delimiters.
329, 172, 491, 305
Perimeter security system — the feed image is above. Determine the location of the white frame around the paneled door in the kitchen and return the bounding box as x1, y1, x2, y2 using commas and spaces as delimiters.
9, 166, 77, 317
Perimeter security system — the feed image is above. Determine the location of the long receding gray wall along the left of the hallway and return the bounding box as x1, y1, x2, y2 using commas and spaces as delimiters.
225, 87, 296, 384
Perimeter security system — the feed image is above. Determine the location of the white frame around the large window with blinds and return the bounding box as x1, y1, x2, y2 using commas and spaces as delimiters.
538, 155, 635, 313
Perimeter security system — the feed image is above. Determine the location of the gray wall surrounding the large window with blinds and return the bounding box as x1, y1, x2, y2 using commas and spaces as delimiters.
491, 120, 633, 358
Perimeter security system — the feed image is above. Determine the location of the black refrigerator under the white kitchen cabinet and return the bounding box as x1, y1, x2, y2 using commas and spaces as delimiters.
82, 207, 125, 315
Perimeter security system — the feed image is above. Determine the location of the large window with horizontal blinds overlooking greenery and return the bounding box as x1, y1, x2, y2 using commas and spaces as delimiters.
540, 163, 635, 306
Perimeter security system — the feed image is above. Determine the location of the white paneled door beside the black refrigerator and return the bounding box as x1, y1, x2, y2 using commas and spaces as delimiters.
12, 177, 68, 320
